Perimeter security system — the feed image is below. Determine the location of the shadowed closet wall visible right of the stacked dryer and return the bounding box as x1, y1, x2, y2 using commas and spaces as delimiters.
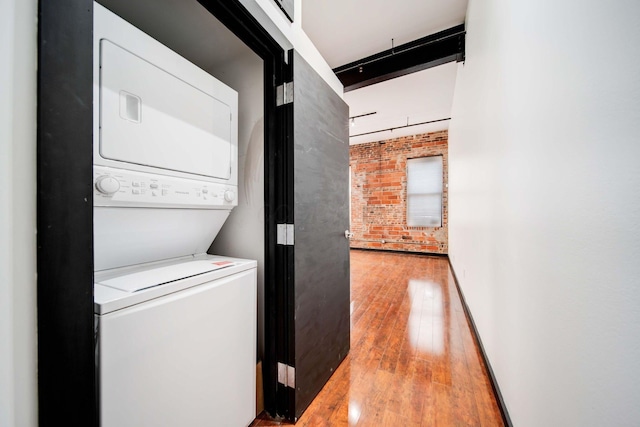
209, 52, 264, 359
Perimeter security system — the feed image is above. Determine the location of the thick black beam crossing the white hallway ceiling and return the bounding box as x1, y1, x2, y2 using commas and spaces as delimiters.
333, 24, 466, 92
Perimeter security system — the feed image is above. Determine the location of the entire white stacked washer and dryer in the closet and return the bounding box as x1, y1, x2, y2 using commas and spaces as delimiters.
93, 3, 257, 427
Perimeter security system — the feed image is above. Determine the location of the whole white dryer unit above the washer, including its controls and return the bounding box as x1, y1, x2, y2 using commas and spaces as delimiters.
93, 2, 238, 271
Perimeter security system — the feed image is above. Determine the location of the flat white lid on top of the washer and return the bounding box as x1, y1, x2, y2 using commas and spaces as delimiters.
98, 260, 236, 293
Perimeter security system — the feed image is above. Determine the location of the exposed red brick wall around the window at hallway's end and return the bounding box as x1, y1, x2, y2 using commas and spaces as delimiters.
349, 130, 448, 254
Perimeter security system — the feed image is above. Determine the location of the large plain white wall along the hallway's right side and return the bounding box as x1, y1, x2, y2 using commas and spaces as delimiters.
449, 0, 640, 427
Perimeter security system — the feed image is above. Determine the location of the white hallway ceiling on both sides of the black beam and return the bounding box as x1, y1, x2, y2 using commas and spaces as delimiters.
302, 0, 467, 144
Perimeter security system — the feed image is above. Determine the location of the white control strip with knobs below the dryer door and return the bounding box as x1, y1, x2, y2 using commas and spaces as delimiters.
93, 165, 238, 209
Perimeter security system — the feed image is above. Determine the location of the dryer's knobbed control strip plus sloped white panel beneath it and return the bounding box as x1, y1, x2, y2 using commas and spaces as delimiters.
93, 166, 237, 271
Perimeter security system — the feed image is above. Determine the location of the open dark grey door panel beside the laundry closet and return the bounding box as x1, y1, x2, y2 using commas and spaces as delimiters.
293, 53, 350, 417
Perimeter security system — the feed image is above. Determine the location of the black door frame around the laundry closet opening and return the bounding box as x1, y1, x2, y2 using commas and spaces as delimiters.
36, 0, 292, 426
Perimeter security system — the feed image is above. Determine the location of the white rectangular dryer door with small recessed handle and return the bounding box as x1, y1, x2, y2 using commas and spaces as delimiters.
99, 39, 233, 180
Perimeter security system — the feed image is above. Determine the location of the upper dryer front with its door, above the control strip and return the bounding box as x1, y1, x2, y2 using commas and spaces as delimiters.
93, 3, 238, 185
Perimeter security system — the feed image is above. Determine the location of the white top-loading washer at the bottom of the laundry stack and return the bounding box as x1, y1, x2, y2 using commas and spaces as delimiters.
95, 255, 256, 427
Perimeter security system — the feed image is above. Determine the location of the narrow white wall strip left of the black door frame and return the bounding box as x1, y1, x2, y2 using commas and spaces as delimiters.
0, 0, 37, 427
